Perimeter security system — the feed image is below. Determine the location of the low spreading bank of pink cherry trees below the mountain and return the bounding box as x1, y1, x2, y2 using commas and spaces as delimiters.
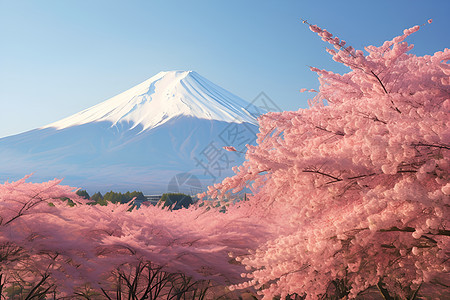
0, 178, 264, 299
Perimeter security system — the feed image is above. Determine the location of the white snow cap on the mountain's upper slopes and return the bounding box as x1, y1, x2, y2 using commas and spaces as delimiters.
43, 71, 258, 131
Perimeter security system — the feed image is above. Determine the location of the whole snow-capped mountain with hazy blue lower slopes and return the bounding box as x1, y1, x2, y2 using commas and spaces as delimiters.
0, 71, 262, 194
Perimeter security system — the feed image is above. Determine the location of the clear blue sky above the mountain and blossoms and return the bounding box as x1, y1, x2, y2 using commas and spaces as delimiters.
0, 0, 450, 137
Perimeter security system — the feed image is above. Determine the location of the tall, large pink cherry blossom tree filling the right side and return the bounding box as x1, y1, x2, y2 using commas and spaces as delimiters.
208, 20, 450, 299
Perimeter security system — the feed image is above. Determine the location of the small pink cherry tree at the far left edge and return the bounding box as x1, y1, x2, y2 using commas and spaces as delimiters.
0, 178, 85, 297
